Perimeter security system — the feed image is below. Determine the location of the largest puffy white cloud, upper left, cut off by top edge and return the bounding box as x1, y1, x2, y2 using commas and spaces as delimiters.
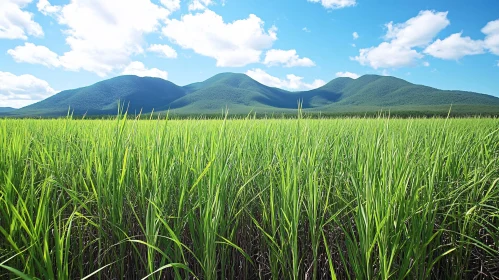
38, 0, 170, 76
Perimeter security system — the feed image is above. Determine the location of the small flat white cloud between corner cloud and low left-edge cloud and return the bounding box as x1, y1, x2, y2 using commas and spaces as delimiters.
7, 43, 61, 67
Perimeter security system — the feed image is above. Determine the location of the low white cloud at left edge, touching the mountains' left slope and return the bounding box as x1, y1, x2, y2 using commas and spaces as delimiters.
0, 71, 56, 108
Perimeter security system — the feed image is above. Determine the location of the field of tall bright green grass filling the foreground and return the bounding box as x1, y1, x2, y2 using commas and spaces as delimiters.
0, 119, 499, 279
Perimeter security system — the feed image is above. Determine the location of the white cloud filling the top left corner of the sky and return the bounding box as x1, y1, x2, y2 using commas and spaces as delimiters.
0, 0, 43, 40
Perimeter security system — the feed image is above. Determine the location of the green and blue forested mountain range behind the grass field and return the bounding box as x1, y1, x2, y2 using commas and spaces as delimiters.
0, 73, 499, 117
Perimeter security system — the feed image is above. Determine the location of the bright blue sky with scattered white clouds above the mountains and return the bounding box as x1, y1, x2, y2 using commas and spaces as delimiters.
0, 0, 499, 108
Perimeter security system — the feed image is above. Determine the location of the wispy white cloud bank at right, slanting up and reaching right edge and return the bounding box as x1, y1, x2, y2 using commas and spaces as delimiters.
351, 11, 499, 66
